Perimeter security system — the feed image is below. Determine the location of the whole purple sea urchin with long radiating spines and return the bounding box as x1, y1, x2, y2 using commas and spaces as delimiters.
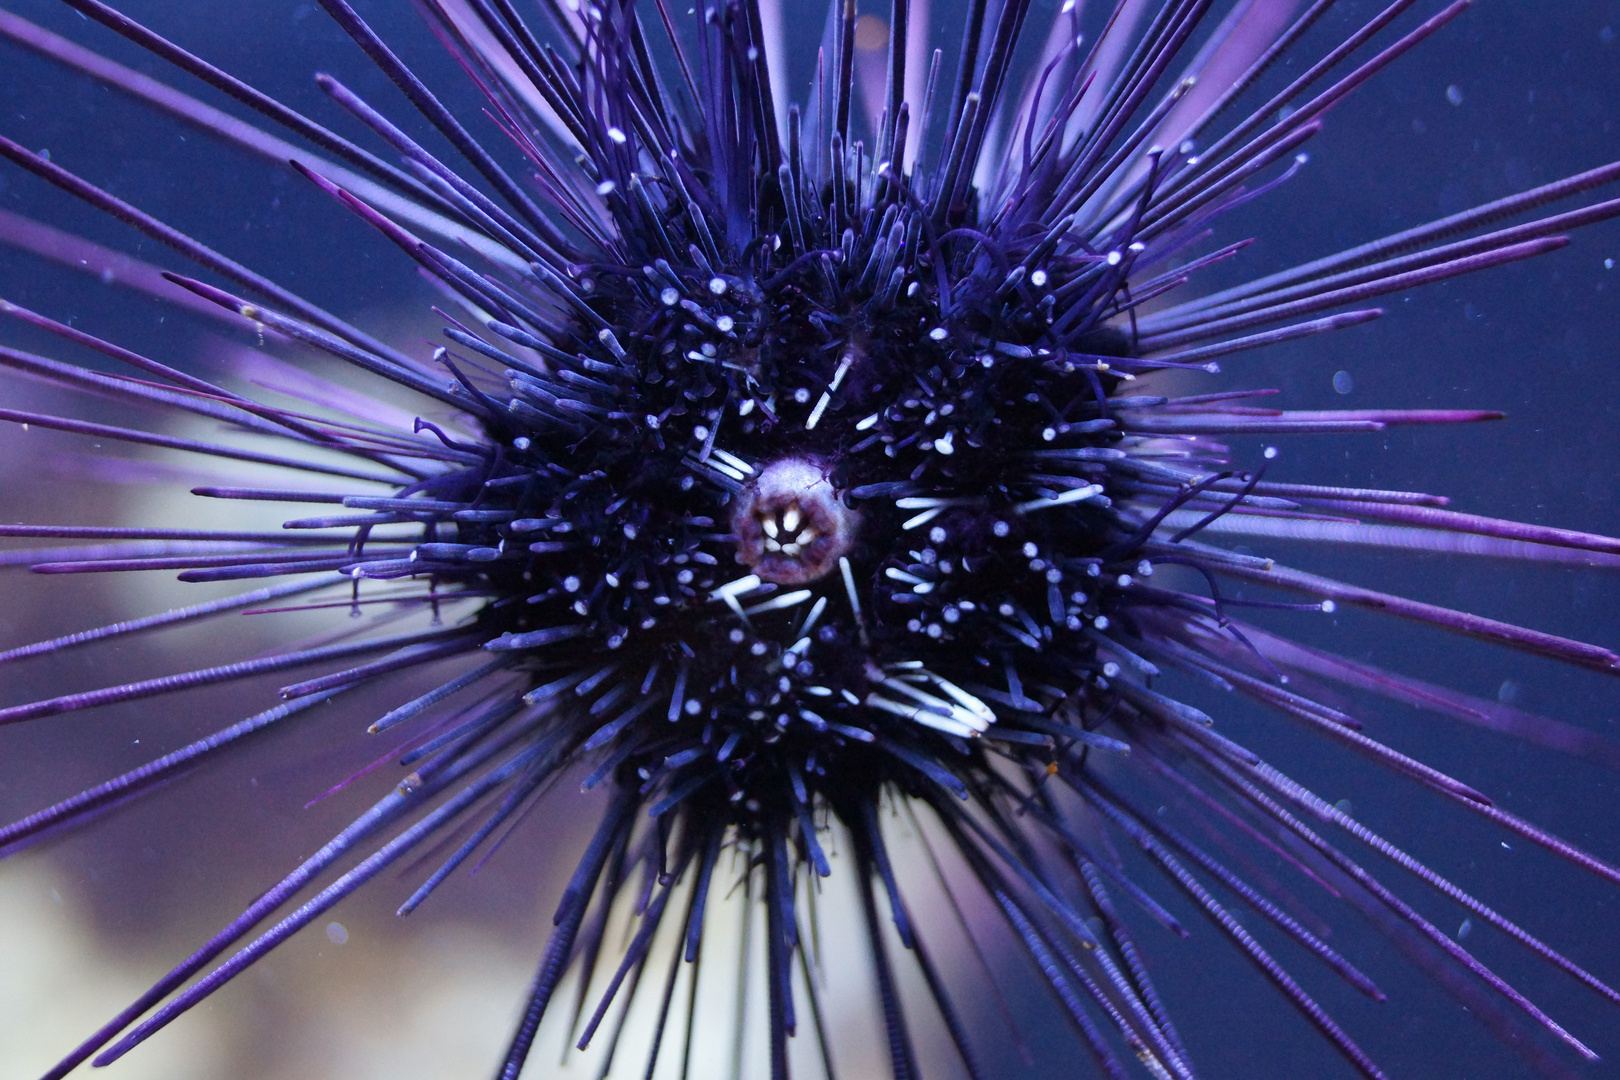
3, 3, 1614, 1075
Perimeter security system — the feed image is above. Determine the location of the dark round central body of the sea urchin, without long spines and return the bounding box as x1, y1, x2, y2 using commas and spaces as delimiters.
469, 181, 1152, 847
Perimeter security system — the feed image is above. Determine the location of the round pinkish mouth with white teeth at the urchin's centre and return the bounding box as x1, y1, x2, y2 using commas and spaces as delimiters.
731, 457, 860, 585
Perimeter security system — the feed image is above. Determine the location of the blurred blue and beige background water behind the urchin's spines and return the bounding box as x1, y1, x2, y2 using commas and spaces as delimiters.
0, 0, 1620, 1080
